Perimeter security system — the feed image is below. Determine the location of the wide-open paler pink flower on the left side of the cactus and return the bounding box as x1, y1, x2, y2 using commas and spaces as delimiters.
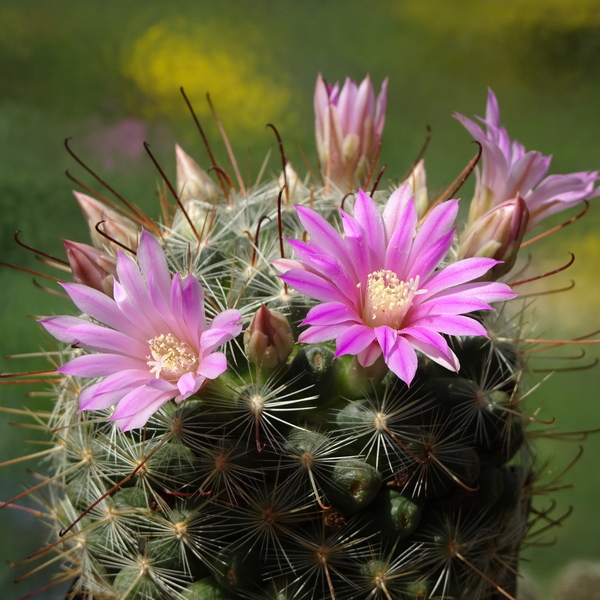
41, 231, 242, 431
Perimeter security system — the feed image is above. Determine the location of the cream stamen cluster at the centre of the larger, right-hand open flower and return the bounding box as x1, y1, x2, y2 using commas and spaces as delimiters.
359, 269, 427, 329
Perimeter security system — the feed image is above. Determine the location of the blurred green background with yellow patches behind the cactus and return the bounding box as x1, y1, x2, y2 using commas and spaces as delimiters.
0, 0, 600, 600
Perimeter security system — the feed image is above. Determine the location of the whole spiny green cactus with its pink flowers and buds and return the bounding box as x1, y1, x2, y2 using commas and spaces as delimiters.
2, 78, 595, 600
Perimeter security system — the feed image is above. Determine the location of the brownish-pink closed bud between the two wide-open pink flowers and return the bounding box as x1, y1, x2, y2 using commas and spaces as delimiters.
244, 304, 294, 369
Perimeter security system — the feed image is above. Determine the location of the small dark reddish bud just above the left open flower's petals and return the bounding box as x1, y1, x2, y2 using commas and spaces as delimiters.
63, 240, 117, 297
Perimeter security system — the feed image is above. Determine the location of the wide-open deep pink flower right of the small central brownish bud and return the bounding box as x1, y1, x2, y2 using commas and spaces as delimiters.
275, 184, 515, 384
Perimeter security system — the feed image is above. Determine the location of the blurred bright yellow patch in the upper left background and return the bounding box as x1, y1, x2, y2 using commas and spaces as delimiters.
123, 19, 290, 131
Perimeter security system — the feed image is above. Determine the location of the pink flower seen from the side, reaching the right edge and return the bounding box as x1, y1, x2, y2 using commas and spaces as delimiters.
455, 90, 600, 231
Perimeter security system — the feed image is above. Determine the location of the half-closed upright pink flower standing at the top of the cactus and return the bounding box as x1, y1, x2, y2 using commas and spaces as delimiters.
314, 75, 387, 193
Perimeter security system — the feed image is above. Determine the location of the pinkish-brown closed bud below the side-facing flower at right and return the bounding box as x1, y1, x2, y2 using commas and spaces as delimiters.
458, 195, 529, 280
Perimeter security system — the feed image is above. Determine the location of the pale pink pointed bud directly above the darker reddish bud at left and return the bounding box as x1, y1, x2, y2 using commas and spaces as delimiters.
73, 192, 140, 254
